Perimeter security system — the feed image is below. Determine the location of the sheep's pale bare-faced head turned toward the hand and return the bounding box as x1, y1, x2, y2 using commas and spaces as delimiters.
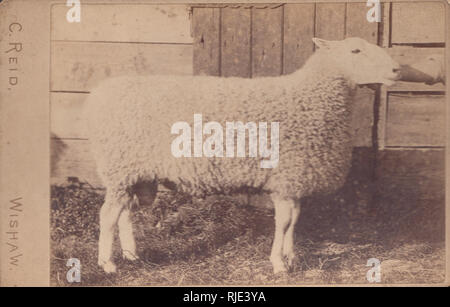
313, 37, 400, 85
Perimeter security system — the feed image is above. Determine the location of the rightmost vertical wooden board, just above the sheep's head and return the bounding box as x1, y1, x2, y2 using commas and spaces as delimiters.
345, 3, 378, 44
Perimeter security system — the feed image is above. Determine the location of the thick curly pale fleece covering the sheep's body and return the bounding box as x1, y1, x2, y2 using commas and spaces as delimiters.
87, 52, 355, 199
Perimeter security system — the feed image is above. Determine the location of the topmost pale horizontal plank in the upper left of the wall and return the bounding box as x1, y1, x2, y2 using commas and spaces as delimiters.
52, 3, 192, 43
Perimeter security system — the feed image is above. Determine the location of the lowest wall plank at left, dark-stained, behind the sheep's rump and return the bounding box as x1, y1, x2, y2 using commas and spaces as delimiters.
50, 138, 102, 188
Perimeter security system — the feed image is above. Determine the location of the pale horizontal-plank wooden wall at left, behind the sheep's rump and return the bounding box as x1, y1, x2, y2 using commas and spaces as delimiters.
50, 4, 193, 187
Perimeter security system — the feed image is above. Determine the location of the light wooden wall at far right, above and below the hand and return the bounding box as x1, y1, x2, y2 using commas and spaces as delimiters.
378, 2, 446, 149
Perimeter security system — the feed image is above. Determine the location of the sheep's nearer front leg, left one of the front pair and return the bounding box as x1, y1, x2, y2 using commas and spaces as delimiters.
270, 194, 294, 274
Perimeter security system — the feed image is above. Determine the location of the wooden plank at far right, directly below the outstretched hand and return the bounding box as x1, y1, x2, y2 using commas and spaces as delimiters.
385, 94, 446, 147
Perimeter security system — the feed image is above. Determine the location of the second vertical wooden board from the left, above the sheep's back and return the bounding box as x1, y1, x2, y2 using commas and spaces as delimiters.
221, 7, 251, 78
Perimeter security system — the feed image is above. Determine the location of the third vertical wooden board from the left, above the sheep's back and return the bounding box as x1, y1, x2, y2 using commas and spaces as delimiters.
252, 6, 283, 77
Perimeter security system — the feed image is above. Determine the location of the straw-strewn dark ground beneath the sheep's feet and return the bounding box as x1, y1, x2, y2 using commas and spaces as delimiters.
51, 183, 445, 286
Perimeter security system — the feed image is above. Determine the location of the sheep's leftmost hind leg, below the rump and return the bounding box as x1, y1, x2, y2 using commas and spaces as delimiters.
98, 191, 131, 273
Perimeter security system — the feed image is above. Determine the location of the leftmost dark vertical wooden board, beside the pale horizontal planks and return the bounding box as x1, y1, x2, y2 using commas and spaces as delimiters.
192, 8, 220, 76
